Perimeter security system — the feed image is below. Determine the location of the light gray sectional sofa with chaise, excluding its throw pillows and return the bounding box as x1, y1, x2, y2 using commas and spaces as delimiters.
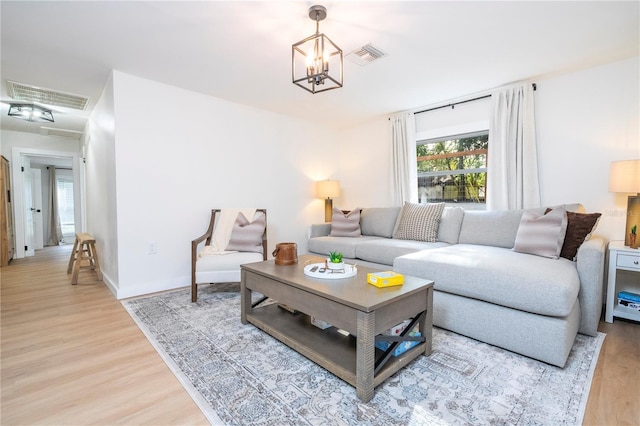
307, 204, 605, 367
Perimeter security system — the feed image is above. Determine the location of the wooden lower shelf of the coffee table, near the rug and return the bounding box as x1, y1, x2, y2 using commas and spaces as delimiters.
247, 304, 427, 387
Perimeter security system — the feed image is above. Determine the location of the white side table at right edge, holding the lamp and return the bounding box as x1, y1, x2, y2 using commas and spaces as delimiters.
604, 241, 640, 322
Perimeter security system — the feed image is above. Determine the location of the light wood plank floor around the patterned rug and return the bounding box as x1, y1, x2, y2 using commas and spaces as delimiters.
0, 246, 640, 426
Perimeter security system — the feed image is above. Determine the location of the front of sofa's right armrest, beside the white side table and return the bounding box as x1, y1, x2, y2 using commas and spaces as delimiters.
576, 237, 605, 336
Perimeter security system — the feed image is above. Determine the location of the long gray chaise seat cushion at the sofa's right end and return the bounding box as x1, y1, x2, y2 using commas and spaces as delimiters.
393, 244, 580, 317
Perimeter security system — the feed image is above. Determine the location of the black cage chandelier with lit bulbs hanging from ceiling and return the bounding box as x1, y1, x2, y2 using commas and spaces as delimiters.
291, 5, 342, 93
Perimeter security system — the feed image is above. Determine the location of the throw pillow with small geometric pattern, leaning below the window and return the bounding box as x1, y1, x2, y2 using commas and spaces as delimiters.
393, 202, 444, 243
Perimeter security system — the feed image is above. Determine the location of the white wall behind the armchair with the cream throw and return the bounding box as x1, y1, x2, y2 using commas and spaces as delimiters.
99, 72, 339, 298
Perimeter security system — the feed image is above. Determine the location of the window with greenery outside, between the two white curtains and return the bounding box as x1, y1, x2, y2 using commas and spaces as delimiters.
416, 130, 489, 207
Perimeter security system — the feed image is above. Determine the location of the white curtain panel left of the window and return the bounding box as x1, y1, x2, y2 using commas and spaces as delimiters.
389, 112, 418, 206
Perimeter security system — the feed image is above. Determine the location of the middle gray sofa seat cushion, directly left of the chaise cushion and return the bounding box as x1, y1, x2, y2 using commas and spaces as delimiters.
356, 238, 449, 265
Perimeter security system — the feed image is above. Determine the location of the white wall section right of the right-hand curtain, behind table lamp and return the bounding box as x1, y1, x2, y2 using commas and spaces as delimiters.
536, 57, 640, 240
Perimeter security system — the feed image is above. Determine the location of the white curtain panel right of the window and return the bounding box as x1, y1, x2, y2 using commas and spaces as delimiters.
487, 84, 540, 210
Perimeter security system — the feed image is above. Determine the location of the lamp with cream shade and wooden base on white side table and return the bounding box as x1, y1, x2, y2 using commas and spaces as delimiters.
609, 160, 640, 248
